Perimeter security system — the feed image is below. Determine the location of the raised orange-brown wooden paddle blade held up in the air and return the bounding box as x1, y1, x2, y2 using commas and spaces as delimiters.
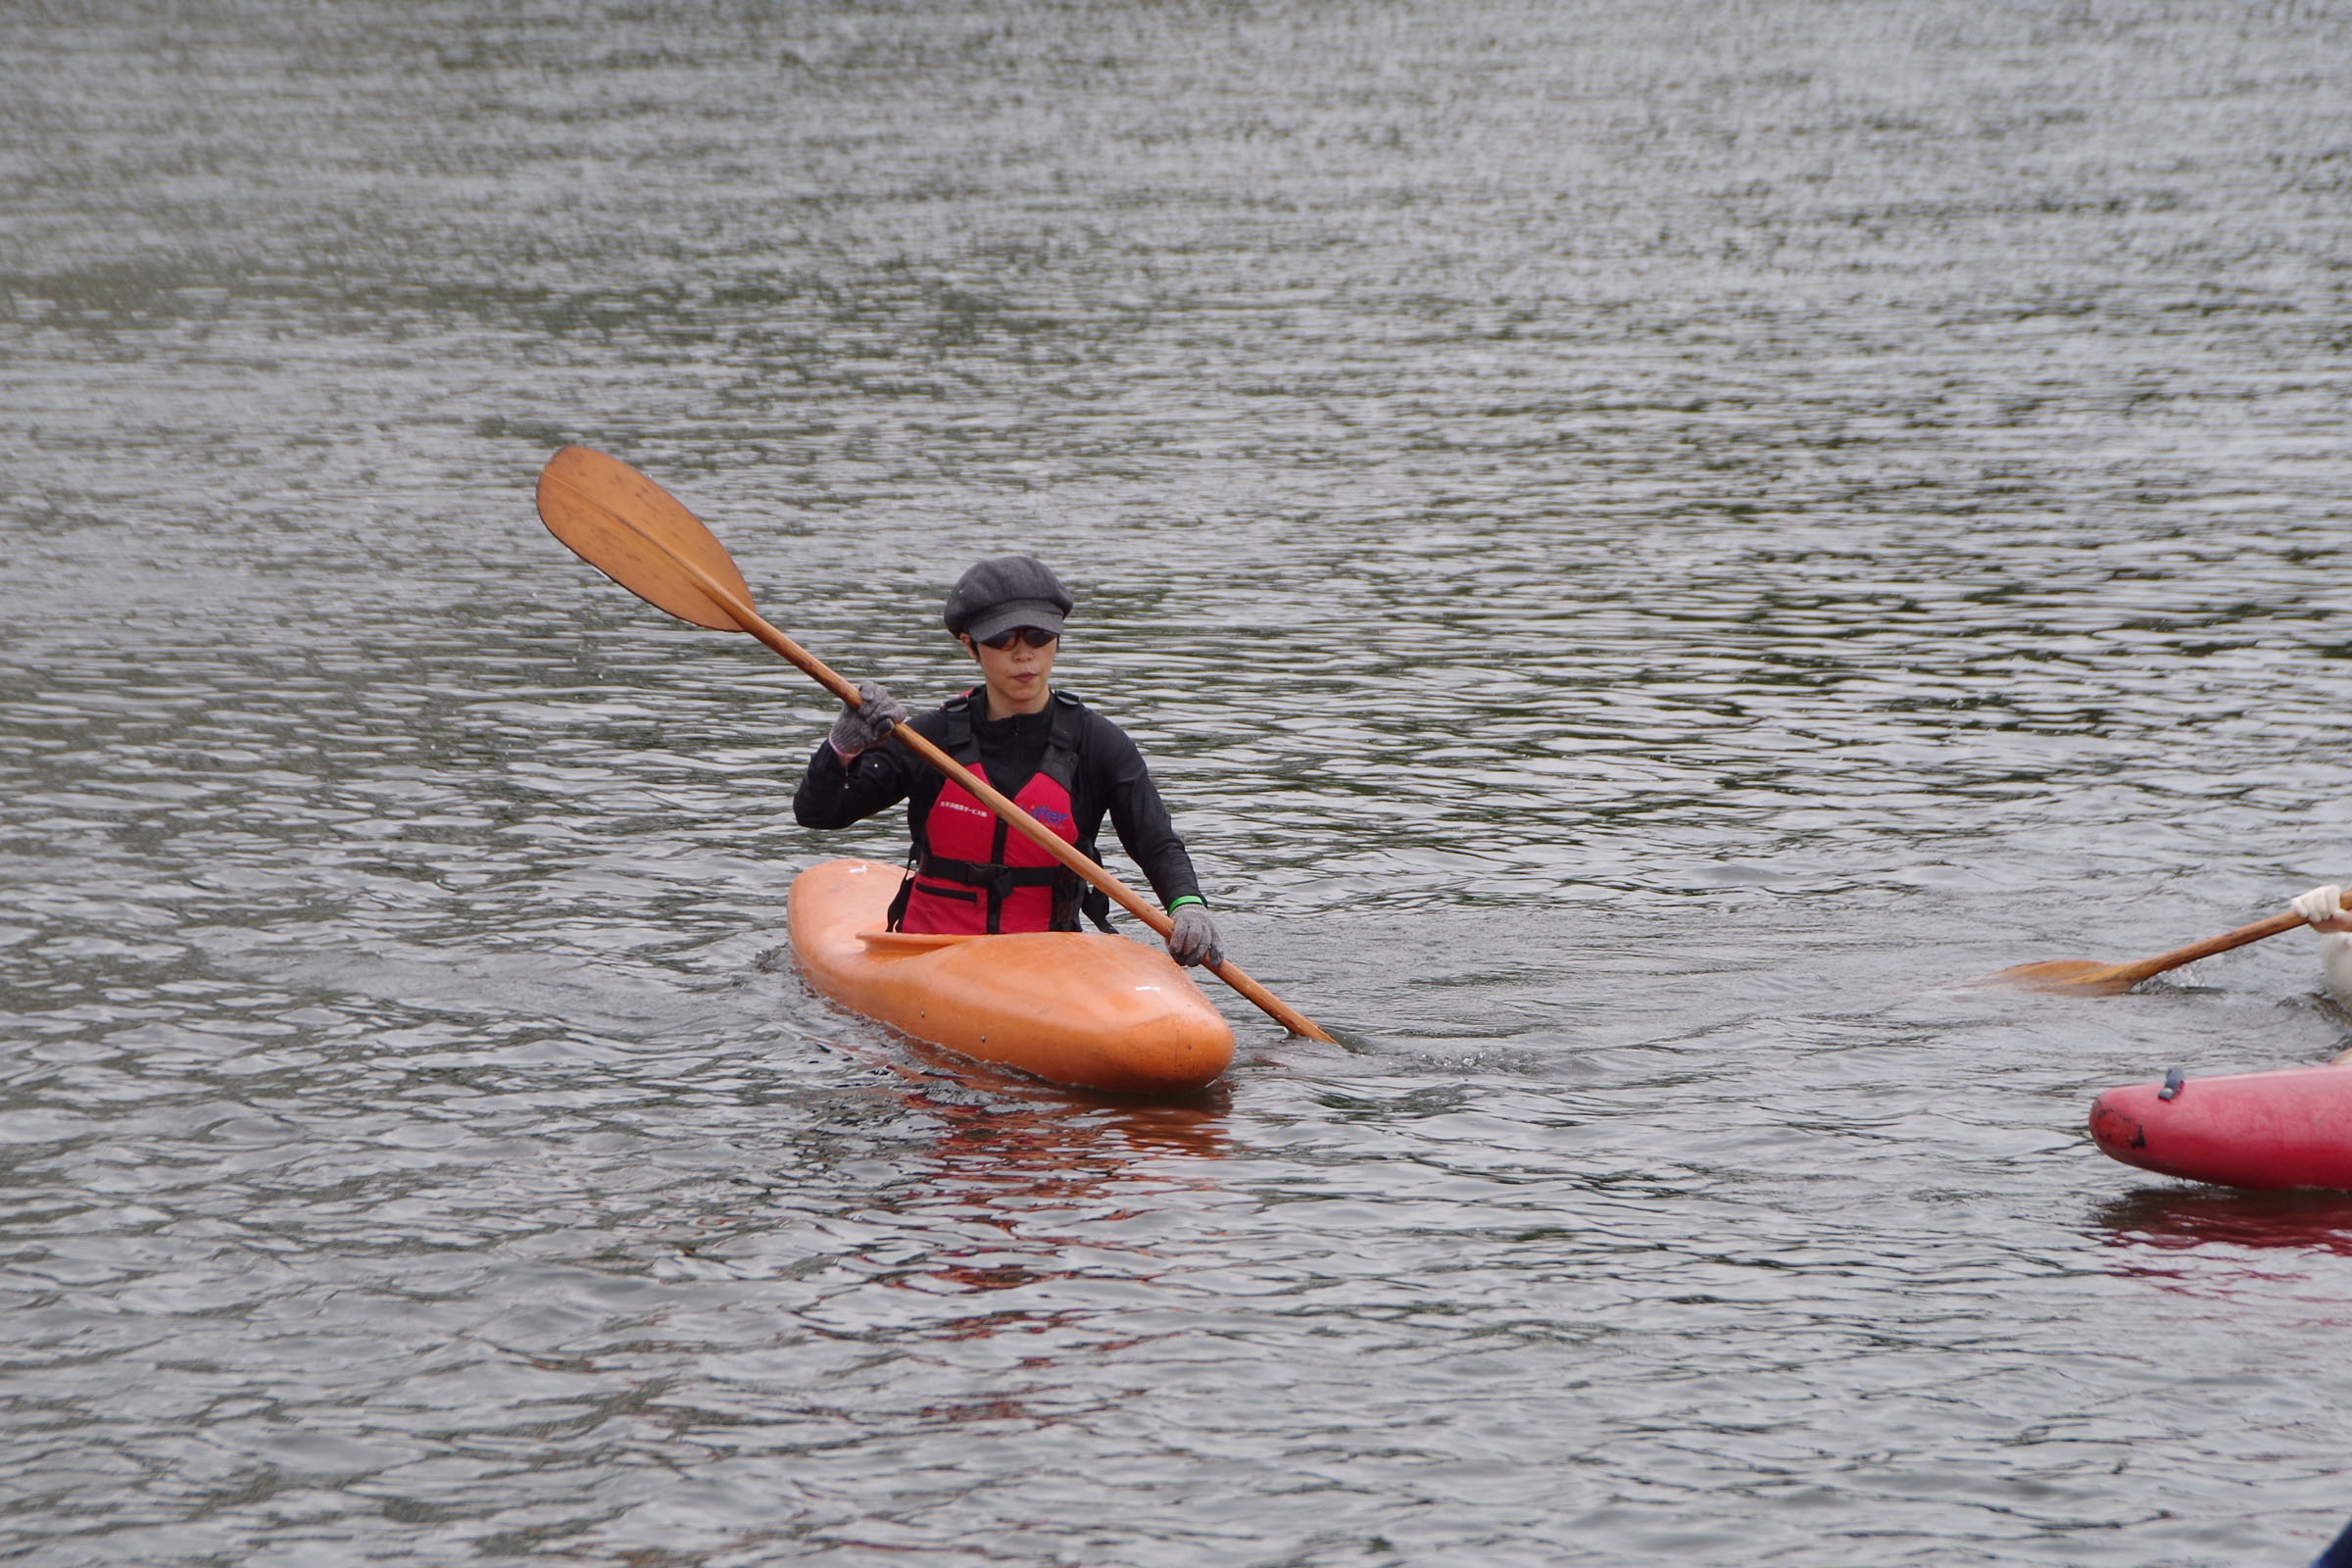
539, 447, 751, 632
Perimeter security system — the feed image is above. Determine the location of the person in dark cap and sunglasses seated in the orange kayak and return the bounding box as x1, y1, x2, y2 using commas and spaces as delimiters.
793, 555, 1223, 966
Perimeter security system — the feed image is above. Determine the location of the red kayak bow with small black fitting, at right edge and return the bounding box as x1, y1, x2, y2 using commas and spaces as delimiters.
2091, 1067, 2352, 1190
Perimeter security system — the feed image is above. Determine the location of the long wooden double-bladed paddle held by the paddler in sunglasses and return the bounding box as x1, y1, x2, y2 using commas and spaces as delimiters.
539, 447, 1331, 1042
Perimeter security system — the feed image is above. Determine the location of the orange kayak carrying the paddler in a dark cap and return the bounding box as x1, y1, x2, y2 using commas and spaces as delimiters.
790, 860, 1233, 1096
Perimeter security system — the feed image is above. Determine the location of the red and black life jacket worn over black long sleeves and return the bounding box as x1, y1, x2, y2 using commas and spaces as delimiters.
892, 691, 1084, 933
